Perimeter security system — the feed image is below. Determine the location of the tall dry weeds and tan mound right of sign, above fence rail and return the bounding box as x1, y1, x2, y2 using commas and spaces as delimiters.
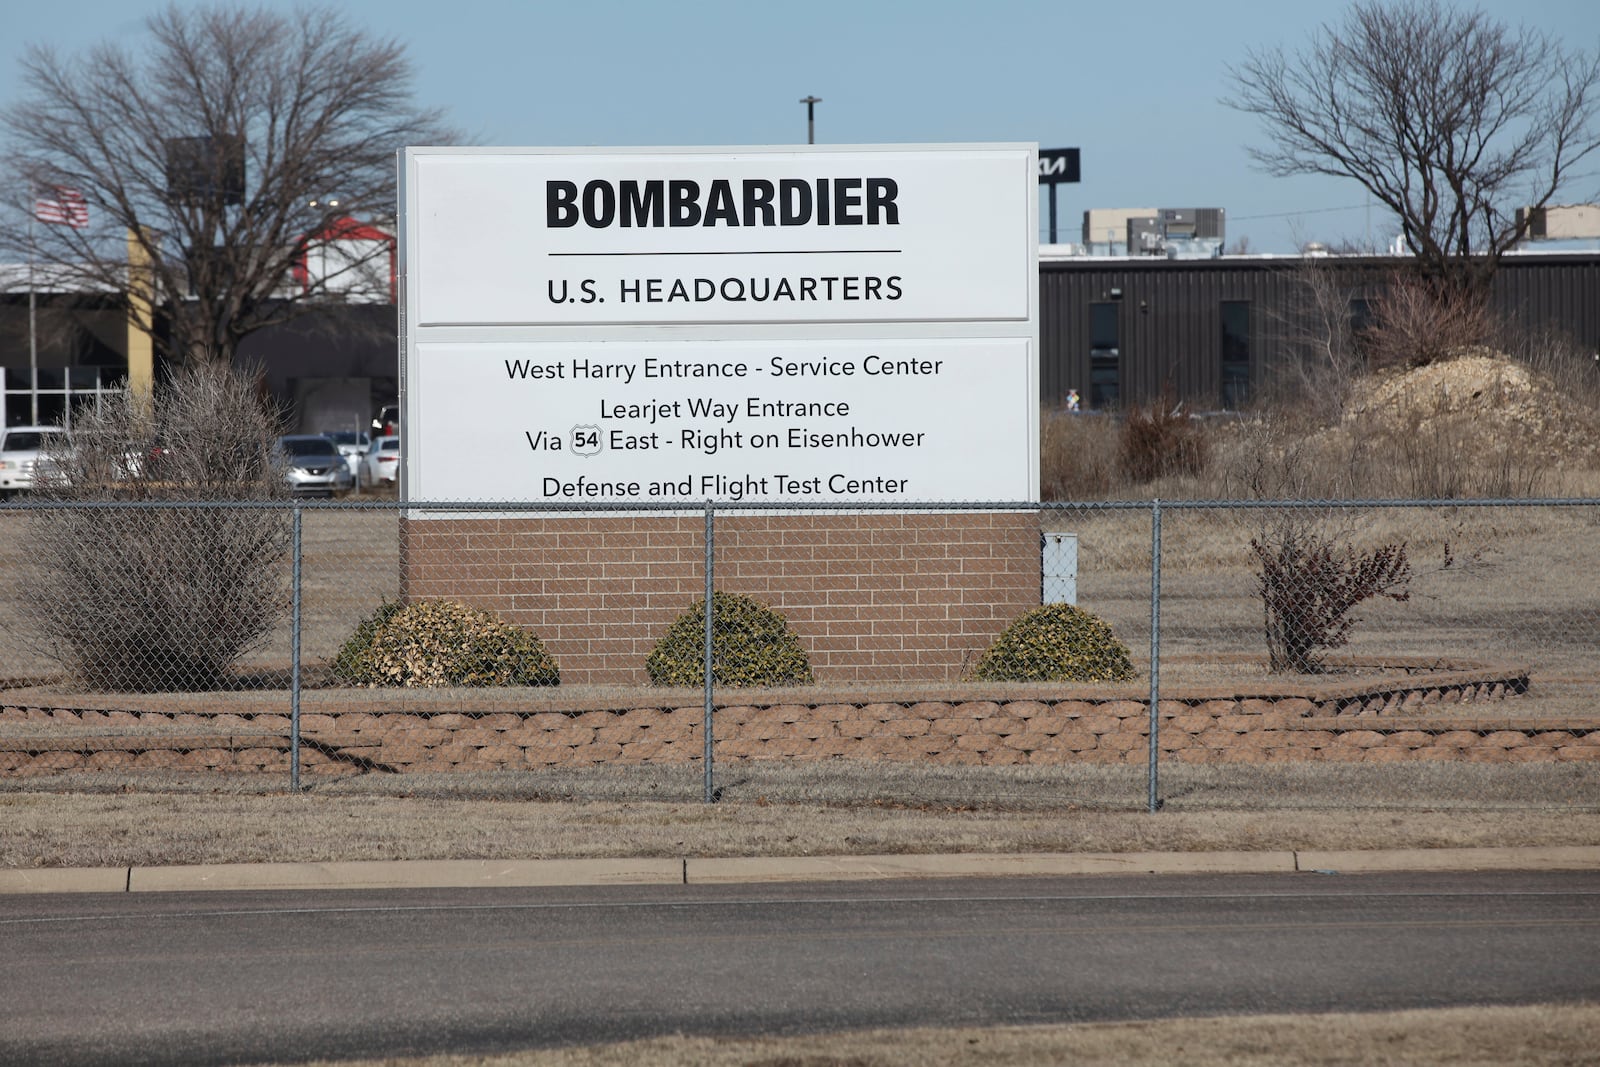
1040, 347, 1600, 501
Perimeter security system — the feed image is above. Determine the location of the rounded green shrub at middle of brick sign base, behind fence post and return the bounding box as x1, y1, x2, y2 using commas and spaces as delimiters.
645, 593, 811, 686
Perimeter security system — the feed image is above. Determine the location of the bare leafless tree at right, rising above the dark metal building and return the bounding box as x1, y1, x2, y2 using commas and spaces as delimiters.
1224, 0, 1600, 296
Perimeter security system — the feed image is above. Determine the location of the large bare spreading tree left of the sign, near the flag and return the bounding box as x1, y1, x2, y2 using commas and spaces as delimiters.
0, 5, 453, 362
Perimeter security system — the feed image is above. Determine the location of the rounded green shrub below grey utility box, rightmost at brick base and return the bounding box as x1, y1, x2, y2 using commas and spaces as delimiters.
973, 605, 1133, 681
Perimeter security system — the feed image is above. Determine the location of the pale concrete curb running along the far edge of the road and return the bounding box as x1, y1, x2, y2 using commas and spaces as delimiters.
0, 846, 1600, 896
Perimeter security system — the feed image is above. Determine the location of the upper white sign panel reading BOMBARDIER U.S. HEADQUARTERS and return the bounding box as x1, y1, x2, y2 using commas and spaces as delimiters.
411, 149, 1035, 326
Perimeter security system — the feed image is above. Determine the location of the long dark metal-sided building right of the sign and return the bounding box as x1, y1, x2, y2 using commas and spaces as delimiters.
1038, 251, 1600, 410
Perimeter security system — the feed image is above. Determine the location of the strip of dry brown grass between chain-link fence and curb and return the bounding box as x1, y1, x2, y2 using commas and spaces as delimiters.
0, 763, 1600, 867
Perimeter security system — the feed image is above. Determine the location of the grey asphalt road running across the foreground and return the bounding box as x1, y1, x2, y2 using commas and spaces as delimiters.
0, 872, 1600, 1064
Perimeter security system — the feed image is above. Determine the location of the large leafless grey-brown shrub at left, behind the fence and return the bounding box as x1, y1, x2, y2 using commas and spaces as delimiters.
21, 362, 290, 691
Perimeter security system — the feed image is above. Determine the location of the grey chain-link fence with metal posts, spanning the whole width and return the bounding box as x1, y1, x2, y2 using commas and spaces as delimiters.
0, 496, 1600, 809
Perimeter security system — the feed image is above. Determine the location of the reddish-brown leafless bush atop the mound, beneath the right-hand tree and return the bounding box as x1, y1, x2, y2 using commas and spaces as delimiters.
1360, 275, 1494, 371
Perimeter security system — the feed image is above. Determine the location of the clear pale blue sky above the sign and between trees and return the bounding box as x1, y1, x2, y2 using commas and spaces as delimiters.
0, 0, 1600, 251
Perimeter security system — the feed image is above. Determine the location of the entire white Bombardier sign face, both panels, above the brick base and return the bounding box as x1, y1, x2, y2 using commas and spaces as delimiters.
400, 146, 1038, 506
